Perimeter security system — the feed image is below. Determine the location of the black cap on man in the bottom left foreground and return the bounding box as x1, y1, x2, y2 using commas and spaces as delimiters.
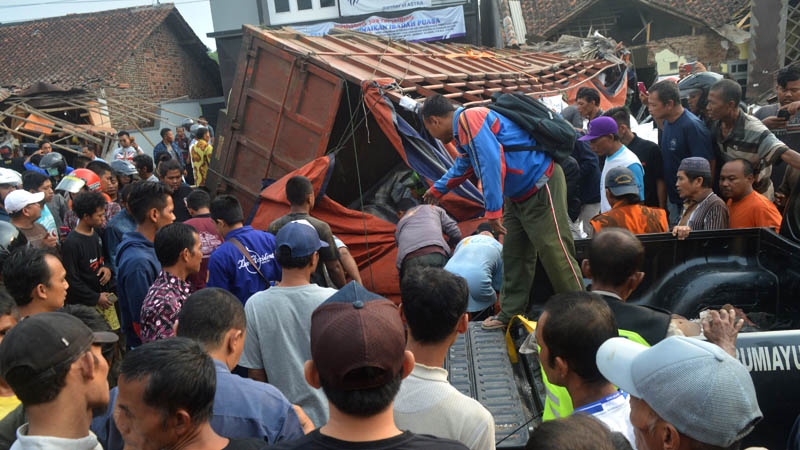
0, 312, 118, 381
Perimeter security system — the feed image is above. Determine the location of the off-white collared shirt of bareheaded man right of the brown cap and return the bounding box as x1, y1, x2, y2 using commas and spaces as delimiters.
393, 363, 494, 450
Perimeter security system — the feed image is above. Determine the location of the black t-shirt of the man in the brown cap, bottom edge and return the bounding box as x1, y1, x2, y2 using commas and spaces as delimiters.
271, 428, 467, 450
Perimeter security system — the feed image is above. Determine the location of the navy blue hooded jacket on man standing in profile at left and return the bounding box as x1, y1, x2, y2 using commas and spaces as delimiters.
116, 231, 161, 347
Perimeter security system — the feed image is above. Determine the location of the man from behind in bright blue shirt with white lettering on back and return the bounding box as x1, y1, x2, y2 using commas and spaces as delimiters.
206, 195, 281, 304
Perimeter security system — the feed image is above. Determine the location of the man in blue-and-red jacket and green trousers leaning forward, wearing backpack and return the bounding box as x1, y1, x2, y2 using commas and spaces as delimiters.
422, 95, 583, 329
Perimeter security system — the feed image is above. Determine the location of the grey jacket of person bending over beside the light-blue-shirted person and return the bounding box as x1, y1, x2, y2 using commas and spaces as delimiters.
394, 205, 461, 270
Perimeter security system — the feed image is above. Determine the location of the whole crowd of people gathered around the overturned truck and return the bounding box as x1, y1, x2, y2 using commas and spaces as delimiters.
0, 62, 800, 450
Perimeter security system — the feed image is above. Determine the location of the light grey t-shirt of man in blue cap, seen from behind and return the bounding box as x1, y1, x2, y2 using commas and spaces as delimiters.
239, 284, 336, 427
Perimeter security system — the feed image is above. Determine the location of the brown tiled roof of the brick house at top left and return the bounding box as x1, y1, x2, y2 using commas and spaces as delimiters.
0, 5, 206, 88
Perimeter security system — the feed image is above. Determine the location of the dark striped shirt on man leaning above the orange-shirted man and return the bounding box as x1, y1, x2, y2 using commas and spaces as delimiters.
711, 111, 789, 199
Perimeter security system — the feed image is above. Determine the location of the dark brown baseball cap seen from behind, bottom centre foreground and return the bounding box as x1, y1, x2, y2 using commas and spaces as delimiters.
311, 281, 406, 391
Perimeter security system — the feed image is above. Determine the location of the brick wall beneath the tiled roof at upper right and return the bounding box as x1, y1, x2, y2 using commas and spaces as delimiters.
647, 30, 739, 71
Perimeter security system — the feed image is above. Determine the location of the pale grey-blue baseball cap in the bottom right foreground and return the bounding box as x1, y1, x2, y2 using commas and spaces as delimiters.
596, 336, 763, 447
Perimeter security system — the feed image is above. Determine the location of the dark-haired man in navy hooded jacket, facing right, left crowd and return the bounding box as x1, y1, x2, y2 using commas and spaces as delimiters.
116, 181, 175, 348
